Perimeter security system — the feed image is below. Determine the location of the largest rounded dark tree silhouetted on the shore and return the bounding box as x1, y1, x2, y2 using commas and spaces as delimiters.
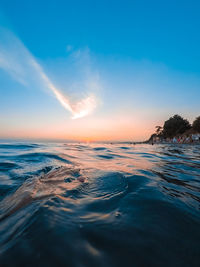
163, 115, 191, 138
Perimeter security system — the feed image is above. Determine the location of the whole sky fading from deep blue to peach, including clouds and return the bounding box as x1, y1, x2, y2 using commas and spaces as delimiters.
0, 0, 200, 141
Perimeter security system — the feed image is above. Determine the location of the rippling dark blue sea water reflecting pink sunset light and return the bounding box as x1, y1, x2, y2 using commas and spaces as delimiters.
0, 142, 200, 267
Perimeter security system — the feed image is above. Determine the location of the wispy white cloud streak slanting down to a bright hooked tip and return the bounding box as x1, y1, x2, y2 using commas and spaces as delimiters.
0, 28, 97, 119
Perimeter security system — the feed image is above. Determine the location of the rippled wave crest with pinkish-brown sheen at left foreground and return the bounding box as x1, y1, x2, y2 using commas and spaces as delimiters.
0, 166, 85, 221
